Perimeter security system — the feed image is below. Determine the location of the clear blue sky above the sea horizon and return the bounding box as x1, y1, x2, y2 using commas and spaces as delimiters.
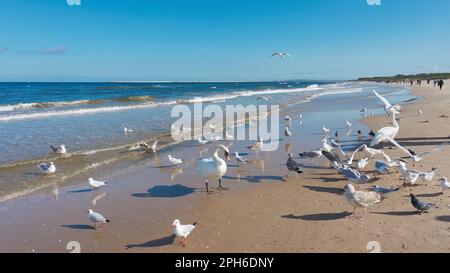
0, 0, 450, 81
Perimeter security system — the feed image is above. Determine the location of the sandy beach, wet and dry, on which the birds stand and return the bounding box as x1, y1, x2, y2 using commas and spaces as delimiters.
0, 83, 450, 252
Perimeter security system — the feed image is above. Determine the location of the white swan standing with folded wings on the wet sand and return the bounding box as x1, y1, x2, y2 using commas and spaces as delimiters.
197, 145, 230, 193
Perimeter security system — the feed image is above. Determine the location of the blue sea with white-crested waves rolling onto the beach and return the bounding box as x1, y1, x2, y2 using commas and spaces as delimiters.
0, 82, 411, 201
